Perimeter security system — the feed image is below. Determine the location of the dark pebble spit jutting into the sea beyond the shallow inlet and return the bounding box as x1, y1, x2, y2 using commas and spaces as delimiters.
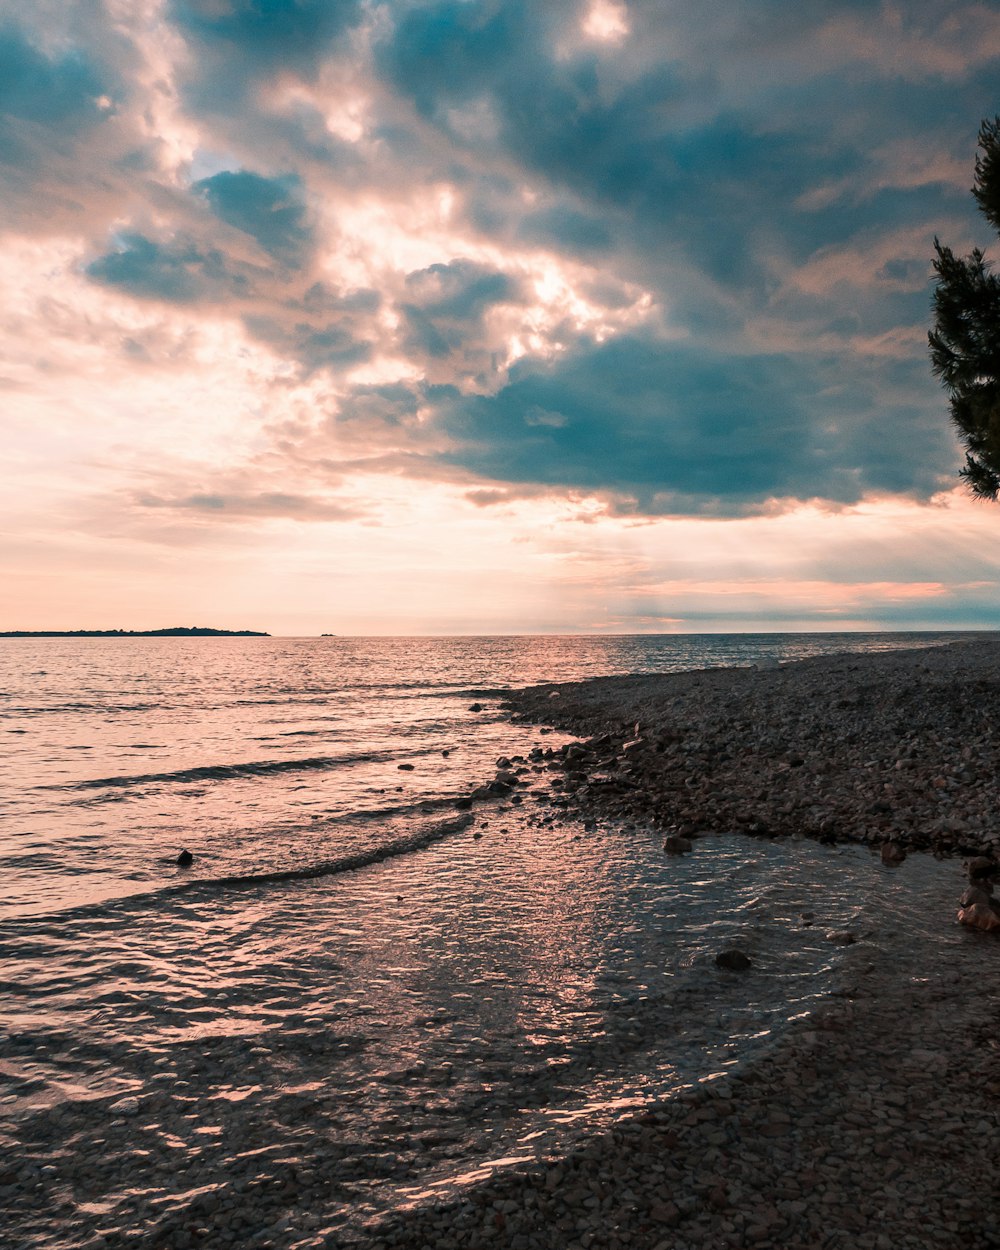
510, 641, 1000, 864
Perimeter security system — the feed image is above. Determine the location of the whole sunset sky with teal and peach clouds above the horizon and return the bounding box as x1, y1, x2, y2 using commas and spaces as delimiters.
0, 0, 1000, 635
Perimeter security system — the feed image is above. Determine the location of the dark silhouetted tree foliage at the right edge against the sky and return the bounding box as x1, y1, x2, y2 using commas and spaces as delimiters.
928, 118, 1000, 500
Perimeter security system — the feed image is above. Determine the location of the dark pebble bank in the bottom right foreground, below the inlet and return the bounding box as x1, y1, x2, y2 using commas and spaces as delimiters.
365, 933, 1000, 1250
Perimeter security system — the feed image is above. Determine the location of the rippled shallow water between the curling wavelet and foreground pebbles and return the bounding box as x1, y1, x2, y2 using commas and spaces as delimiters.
0, 811, 960, 1246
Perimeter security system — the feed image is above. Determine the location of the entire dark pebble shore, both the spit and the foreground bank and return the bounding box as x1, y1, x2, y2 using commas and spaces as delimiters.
370, 643, 1000, 1250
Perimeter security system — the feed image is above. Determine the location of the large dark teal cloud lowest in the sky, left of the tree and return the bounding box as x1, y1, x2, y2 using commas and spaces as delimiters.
429, 336, 945, 515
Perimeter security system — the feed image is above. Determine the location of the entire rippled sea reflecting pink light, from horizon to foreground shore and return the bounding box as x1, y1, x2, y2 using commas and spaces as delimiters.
0, 633, 985, 1248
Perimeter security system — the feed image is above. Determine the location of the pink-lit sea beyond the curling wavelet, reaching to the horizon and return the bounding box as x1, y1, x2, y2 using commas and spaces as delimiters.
0, 634, 985, 915
